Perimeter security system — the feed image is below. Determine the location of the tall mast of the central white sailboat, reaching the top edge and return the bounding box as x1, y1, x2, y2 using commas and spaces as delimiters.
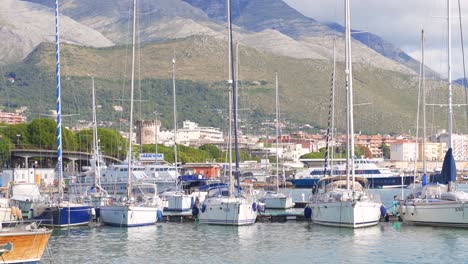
227, 0, 240, 186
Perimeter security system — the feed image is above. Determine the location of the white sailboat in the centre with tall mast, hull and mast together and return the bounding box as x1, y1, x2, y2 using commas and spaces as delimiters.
198, 0, 258, 226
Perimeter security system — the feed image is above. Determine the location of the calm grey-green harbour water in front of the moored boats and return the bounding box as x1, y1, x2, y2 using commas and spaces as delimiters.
42, 186, 468, 264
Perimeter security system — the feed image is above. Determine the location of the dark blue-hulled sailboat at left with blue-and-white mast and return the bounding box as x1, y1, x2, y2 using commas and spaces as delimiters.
31, 0, 91, 227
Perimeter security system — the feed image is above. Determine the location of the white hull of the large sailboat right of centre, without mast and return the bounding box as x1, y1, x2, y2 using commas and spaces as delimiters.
311, 200, 381, 228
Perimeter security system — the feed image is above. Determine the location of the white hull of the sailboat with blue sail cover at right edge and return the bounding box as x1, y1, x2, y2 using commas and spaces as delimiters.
399, 200, 468, 227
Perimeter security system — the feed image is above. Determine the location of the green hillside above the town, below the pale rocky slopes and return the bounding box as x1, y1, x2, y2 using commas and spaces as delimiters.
0, 37, 464, 133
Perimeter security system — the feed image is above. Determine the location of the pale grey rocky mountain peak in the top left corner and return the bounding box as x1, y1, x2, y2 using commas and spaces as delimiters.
0, 0, 114, 64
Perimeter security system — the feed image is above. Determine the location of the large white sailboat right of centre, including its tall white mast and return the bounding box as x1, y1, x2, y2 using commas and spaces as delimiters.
309, 0, 382, 228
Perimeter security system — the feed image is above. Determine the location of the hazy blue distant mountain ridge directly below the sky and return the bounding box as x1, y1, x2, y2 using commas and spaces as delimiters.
183, 0, 419, 76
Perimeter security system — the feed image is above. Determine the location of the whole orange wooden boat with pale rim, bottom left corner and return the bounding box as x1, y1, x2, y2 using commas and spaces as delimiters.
0, 222, 52, 263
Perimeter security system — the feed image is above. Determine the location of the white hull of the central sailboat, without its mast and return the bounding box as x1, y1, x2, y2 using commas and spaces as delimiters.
199, 197, 257, 226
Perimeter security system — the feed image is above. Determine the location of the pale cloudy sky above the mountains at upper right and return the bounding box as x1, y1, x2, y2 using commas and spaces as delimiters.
283, 0, 468, 79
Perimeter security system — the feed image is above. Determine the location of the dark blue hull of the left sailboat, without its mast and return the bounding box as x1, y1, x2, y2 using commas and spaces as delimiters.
31, 204, 91, 227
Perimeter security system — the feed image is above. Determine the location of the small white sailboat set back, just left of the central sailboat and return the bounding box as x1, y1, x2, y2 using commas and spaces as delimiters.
162, 56, 195, 211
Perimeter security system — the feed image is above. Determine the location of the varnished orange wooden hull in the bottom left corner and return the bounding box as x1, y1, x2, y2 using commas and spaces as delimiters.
0, 229, 52, 263
